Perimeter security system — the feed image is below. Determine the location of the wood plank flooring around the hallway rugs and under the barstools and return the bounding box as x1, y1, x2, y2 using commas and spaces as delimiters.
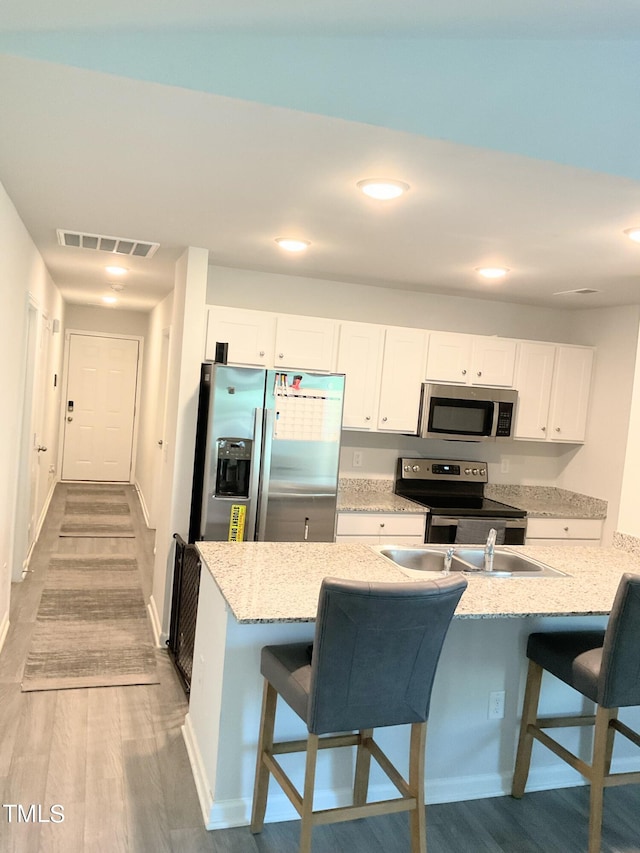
0, 484, 640, 853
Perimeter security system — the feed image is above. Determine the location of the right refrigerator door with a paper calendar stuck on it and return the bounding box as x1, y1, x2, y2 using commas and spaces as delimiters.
257, 371, 344, 542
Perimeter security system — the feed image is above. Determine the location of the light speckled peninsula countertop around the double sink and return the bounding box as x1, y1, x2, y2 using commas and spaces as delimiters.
197, 542, 640, 623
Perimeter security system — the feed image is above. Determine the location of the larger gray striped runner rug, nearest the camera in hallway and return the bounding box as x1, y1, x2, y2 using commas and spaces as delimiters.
22, 554, 159, 692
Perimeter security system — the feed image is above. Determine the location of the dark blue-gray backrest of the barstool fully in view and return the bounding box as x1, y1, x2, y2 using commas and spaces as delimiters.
307, 575, 467, 734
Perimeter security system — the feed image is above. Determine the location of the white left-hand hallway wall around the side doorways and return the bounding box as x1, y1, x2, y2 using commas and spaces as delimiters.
0, 180, 64, 604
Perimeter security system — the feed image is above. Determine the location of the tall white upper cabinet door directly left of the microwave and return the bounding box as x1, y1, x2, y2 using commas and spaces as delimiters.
378, 326, 427, 433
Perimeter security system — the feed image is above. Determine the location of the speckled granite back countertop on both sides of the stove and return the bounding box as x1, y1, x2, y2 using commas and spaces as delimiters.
337, 477, 607, 519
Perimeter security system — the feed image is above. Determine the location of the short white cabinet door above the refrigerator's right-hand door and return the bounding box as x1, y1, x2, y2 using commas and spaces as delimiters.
274, 314, 338, 373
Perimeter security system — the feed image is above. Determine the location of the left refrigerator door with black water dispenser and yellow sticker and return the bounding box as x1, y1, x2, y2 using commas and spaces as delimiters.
202, 365, 265, 541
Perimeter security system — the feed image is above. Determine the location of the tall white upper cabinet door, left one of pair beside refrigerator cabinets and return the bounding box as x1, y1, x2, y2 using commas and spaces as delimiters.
336, 323, 384, 430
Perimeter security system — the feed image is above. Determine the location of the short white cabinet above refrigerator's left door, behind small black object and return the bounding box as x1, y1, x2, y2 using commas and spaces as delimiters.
204, 306, 276, 367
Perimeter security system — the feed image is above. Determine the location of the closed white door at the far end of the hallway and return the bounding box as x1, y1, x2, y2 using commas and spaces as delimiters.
62, 333, 139, 482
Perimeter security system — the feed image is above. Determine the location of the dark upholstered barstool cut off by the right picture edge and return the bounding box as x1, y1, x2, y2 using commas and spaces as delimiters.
512, 574, 640, 853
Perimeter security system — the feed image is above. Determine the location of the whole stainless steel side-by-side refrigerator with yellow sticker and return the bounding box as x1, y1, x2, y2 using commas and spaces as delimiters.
189, 363, 344, 542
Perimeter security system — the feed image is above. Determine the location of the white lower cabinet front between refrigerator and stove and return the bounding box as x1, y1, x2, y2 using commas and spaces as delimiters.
336, 512, 426, 545
